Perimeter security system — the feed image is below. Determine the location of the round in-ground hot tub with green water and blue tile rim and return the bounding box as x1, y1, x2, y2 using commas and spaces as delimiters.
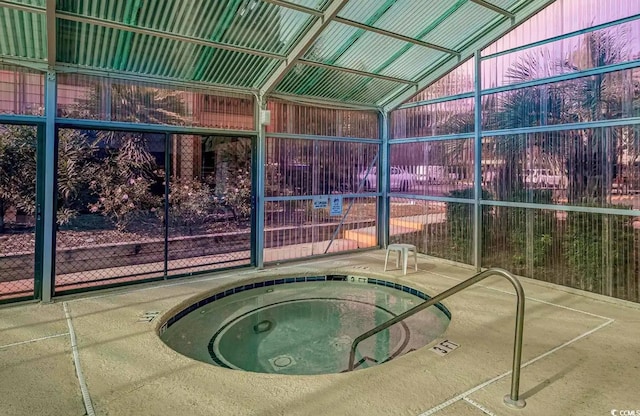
159, 275, 451, 374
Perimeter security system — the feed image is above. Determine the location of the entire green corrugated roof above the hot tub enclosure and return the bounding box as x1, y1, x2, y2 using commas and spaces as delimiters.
0, 0, 548, 105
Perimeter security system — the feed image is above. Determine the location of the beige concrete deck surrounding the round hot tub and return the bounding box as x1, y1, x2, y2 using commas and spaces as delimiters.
0, 250, 640, 416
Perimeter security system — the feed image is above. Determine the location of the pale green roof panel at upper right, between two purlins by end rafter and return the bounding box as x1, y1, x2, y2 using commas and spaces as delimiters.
422, 3, 501, 49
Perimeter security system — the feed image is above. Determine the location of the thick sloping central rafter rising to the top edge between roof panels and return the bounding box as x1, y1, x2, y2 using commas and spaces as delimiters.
260, 0, 349, 96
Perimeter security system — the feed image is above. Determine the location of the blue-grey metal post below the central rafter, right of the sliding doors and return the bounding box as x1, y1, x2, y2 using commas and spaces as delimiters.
253, 95, 267, 269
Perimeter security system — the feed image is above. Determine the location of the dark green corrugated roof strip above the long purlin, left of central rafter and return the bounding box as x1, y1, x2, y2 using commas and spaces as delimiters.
58, 0, 313, 54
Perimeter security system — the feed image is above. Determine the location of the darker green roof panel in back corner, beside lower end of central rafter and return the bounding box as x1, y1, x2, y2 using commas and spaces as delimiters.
276, 65, 403, 103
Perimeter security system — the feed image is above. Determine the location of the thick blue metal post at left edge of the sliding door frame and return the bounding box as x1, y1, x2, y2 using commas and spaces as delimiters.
38, 71, 57, 302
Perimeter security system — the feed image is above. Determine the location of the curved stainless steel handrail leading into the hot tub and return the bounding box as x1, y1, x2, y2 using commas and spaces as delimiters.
349, 268, 526, 409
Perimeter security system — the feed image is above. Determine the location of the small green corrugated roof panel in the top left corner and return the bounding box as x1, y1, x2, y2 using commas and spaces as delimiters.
0, 7, 47, 59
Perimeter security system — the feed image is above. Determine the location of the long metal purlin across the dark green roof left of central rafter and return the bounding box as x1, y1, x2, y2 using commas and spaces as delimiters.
56, 12, 286, 61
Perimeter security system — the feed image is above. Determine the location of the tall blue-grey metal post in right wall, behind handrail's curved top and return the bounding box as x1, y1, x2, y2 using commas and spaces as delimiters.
473, 50, 483, 271
